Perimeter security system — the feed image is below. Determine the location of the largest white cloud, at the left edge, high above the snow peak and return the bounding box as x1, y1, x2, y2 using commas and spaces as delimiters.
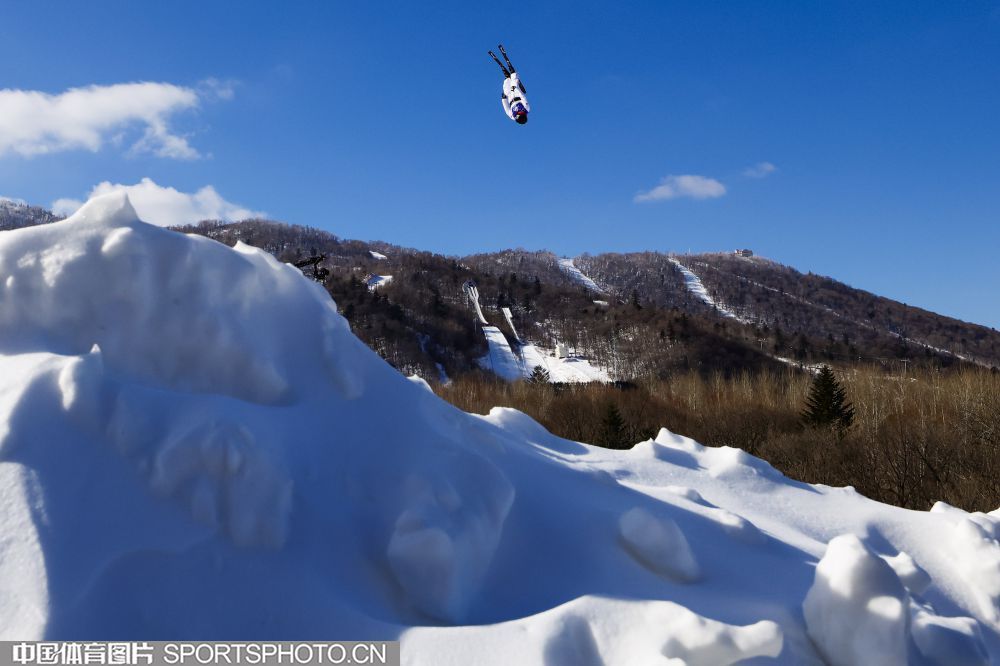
0, 79, 227, 159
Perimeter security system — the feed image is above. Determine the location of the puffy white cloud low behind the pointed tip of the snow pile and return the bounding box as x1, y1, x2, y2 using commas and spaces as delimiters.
52, 178, 266, 227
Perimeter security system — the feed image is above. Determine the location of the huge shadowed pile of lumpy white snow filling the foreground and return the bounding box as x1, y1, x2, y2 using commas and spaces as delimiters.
0, 195, 1000, 666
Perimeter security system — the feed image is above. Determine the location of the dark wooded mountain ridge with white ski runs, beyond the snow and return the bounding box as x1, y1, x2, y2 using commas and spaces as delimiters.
0, 205, 1000, 380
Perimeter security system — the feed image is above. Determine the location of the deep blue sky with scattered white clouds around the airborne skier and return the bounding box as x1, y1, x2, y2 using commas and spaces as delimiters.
0, 1, 1000, 327
